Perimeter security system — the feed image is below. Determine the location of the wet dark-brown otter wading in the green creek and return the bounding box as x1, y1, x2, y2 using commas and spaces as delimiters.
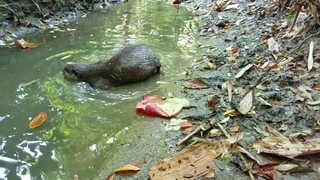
63, 43, 161, 89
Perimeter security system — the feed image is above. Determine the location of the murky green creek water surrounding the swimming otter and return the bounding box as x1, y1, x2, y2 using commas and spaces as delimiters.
0, 0, 196, 179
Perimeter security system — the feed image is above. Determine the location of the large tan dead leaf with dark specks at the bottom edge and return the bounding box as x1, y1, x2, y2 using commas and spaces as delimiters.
148, 137, 241, 180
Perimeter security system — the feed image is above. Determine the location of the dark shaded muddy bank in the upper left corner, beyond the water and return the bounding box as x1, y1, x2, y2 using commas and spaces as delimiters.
0, 0, 125, 47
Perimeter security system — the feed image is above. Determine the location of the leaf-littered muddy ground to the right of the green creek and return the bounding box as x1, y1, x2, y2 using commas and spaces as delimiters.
0, 0, 320, 179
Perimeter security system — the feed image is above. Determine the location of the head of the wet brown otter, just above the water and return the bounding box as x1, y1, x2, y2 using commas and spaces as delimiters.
62, 64, 85, 81
